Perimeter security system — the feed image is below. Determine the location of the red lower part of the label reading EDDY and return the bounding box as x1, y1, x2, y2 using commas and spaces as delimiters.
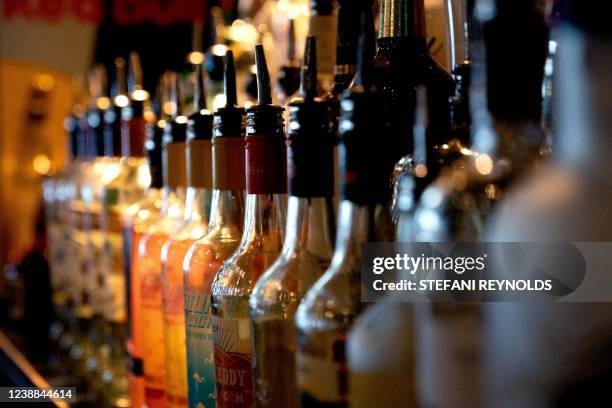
215, 346, 253, 408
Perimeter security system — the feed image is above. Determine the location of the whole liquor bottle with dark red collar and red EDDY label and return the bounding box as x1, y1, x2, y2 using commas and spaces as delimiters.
211, 45, 287, 407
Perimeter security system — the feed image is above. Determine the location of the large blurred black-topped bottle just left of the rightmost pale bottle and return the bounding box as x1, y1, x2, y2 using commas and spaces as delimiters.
413, 0, 546, 407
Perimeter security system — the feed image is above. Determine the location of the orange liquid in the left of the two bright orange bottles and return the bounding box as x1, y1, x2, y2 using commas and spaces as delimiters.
135, 232, 168, 408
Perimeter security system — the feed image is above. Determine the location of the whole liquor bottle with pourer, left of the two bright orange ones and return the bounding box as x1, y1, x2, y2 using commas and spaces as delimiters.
135, 72, 188, 407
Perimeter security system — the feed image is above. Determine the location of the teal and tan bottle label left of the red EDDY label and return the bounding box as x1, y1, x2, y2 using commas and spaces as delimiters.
185, 290, 215, 407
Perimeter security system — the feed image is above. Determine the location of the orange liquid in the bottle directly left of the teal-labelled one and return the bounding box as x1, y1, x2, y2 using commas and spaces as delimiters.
162, 239, 195, 407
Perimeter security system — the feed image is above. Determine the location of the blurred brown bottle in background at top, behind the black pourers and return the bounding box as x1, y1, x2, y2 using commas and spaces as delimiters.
308, 0, 338, 92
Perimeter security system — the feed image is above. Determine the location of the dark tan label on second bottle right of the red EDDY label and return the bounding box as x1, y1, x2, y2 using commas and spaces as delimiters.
296, 339, 348, 406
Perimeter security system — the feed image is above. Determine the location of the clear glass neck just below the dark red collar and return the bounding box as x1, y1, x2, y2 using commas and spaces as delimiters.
240, 194, 287, 250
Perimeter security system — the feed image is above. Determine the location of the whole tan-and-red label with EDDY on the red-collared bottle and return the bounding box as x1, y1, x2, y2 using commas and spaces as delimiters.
213, 316, 253, 408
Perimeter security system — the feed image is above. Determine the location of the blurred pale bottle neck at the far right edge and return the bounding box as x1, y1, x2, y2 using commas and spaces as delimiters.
553, 26, 612, 172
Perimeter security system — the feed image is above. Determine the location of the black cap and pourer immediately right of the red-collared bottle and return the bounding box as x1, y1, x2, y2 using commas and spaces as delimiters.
287, 36, 335, 197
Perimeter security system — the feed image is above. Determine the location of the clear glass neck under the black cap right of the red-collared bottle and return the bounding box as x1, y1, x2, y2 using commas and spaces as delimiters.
283, 196, 333, 260
